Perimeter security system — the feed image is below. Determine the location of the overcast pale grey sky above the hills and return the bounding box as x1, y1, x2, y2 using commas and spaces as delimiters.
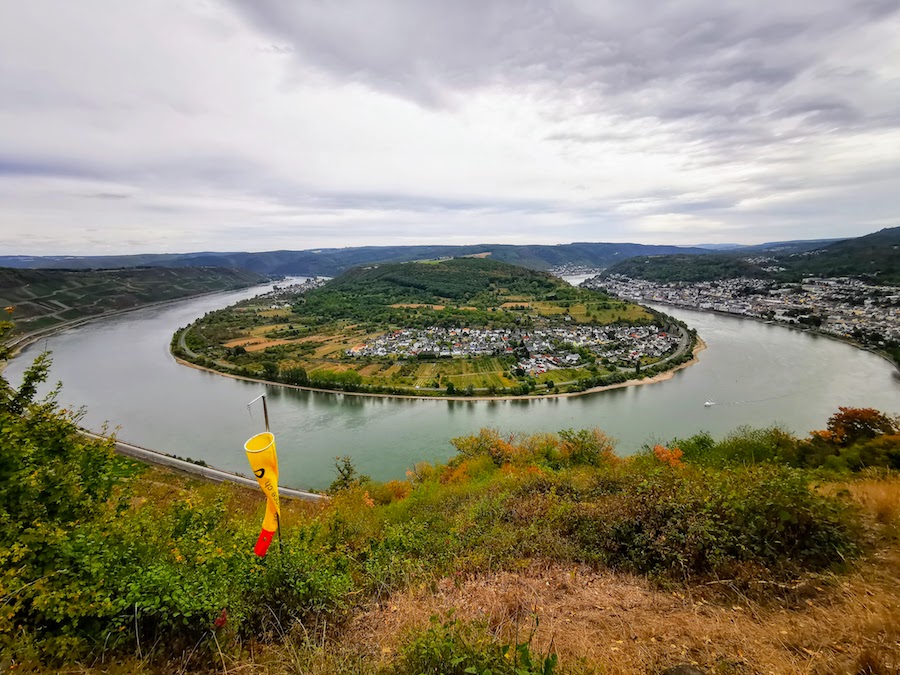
0, 0, 900, 254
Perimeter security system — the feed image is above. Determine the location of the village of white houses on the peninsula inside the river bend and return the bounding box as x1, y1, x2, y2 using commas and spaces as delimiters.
347, 326, 688, 375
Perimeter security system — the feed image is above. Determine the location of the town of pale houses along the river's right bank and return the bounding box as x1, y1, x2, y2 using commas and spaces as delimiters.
583, 274, 900, 347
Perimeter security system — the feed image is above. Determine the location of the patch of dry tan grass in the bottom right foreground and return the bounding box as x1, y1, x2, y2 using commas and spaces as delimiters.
345, 560, 900, 674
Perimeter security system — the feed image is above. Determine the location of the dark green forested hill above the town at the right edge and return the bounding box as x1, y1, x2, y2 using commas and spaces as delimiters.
606, 227, 900, 284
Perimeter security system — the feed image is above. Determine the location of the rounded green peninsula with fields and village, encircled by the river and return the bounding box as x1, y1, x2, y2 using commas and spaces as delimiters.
172, 257, 696, 397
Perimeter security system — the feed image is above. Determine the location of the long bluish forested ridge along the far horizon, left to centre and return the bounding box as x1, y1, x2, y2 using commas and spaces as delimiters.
0, 243, 709, 276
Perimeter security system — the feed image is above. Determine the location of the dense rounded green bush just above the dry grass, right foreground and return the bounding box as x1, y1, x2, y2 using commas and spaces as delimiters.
568, 465, 856, 579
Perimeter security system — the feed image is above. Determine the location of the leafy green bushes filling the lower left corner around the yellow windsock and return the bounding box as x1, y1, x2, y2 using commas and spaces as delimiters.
0, 324, 352, 661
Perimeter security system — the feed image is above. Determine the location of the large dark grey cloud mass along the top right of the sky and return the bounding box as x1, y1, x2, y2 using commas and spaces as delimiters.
233, 0, 900, 147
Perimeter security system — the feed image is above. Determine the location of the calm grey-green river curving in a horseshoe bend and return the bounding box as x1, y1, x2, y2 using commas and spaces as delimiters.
6, 278, 900, 488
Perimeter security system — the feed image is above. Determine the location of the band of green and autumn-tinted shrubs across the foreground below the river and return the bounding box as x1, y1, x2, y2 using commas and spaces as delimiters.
0, 316, 890, 672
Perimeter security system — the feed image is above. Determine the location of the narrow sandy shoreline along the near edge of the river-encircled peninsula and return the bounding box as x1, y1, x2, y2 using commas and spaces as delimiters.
173, 337, 707, 401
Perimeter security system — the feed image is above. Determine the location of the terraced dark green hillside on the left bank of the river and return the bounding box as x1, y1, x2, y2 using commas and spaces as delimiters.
0, 267, 266, 333
